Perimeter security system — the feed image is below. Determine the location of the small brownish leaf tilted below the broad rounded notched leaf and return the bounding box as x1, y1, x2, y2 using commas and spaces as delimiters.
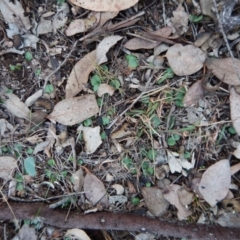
183, 80, 204, 107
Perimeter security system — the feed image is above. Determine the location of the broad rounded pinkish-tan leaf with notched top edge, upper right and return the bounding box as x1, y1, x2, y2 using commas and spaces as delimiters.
166, 43, 206, 76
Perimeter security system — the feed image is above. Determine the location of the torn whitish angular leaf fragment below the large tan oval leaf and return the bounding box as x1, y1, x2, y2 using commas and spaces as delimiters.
77, 125, 102, 154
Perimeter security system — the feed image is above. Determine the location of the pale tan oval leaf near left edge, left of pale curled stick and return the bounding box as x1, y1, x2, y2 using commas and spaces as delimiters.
4, 93, 30, 119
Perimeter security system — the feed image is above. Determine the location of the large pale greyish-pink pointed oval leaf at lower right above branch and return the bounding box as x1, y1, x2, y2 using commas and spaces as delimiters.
198, 159, 231, 207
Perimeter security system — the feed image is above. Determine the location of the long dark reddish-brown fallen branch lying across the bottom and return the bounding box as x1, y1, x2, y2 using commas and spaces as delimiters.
0, 202, 240, 240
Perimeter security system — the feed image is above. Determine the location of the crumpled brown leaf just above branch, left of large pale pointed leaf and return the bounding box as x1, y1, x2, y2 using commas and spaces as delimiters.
163, 184, 192, 220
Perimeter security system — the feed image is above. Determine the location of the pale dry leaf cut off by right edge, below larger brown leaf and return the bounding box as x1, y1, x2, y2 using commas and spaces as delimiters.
229, 86, 240, 136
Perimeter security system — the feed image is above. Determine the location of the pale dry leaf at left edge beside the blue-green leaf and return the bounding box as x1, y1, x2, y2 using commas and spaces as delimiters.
0, 156, 17, 181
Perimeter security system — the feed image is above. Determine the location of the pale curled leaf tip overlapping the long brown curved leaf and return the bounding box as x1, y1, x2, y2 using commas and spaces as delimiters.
96, 35, 123, 65
